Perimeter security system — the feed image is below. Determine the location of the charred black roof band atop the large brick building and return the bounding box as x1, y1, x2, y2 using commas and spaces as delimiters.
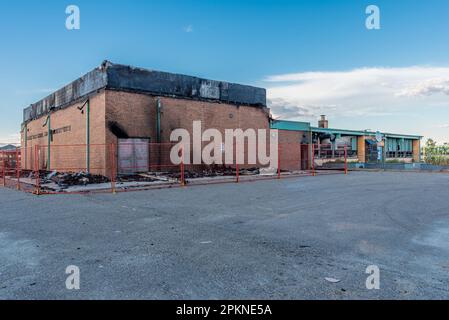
23, 61, 267, 122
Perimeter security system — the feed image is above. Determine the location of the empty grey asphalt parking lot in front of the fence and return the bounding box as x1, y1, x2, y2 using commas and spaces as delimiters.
0, 172, 449, 299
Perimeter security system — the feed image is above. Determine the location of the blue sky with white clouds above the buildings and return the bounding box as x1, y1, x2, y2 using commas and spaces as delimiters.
0, 0, 449, 142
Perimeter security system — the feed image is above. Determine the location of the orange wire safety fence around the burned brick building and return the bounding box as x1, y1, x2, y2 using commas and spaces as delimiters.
0, 139, 351, 194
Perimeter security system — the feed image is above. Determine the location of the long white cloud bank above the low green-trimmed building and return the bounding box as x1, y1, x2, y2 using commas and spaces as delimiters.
265, 66, 449, 120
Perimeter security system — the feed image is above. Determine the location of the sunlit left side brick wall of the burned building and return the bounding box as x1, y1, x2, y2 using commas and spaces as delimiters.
21, 91, 106, 174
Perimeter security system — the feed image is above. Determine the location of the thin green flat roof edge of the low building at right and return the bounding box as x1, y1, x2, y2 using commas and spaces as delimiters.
271, 120, 423, 140
